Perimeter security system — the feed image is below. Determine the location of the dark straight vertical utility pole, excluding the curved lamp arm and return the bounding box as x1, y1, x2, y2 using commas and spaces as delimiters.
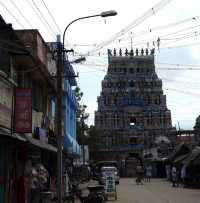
56, 35, 64, 203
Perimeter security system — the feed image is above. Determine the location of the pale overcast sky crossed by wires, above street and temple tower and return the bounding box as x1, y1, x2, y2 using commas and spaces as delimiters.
0, 0, 200, 129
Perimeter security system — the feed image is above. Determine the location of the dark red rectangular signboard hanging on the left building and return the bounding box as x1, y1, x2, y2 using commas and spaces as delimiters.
14, 88, 32, 133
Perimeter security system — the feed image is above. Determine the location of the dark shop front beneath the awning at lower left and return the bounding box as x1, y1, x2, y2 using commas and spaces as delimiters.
0, 131, 57, 203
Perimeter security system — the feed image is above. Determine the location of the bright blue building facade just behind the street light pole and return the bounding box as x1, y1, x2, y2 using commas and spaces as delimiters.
48, 42, 81, 155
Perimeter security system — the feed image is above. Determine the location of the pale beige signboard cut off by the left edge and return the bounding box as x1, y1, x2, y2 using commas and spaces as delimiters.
0, 80, 13, 128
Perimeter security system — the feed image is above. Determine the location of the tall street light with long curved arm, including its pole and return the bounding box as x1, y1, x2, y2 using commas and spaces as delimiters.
56, 10, 117, 203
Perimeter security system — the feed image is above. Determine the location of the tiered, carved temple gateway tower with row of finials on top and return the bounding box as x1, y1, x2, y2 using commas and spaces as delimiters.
95, 49, 172, 162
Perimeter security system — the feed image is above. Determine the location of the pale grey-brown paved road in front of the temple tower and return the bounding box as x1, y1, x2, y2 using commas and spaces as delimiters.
113, 178, 200, 203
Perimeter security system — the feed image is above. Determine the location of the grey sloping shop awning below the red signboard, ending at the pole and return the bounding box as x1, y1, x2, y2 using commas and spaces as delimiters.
25, 135, 57, 152
